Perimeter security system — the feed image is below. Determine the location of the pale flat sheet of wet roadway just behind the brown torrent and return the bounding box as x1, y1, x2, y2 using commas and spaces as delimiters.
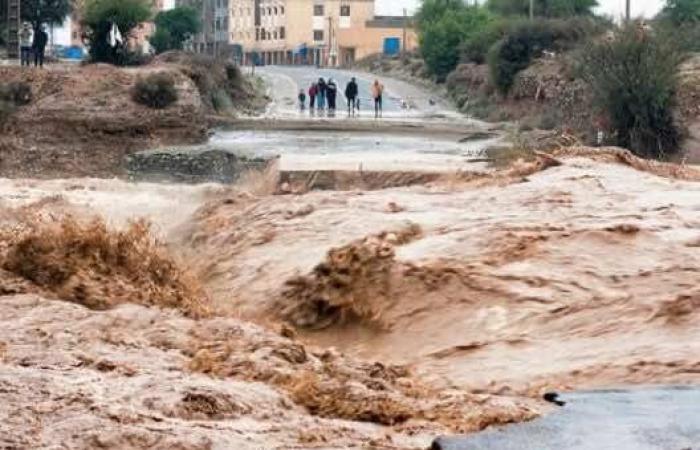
210, 131, 498, 171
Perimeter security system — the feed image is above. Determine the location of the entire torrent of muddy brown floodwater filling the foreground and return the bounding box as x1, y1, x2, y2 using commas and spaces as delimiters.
0, 149, 700, 449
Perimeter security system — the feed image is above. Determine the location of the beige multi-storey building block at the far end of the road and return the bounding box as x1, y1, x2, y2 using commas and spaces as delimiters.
178, 0, 417, 66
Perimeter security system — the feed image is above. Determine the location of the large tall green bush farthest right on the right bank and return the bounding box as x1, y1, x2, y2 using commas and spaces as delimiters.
580, 25, 685, 158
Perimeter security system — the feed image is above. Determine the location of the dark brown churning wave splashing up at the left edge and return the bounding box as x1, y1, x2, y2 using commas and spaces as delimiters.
2, 218, 209, 317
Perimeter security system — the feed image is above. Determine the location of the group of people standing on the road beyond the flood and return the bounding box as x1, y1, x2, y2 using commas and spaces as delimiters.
299, 77, 384, 117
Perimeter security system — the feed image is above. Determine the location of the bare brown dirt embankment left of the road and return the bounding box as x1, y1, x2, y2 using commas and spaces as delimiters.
0, 53, 262, 178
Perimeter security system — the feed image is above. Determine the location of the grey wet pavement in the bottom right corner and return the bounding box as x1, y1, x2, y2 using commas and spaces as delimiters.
432, 387, 700, 450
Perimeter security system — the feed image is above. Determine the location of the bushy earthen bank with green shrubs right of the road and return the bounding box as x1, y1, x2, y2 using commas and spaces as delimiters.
416, 0, 700, 158
